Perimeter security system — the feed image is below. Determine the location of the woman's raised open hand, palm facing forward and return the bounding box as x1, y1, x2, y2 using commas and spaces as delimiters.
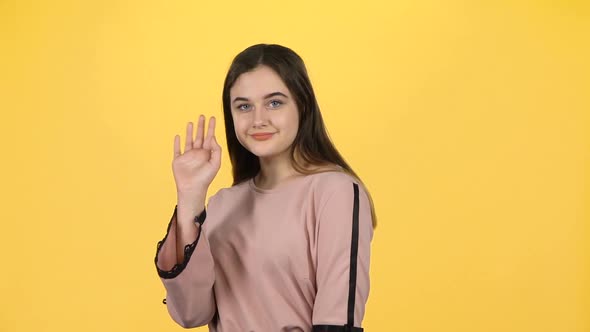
172, 115, 221, 195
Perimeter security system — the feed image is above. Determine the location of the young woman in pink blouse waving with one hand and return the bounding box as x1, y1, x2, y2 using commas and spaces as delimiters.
155, 44, 375, 332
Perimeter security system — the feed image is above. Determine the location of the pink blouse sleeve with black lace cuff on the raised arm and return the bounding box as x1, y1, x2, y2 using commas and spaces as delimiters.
155, 207, 216, 328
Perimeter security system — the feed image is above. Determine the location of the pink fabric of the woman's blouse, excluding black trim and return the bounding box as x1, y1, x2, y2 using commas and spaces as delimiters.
159, 172, 373, 332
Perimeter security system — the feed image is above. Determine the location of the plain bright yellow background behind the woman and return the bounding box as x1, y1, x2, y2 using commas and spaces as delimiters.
0, 0, 590, 332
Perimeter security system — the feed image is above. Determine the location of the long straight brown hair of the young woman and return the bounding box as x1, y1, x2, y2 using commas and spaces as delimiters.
222, 44, 377, 227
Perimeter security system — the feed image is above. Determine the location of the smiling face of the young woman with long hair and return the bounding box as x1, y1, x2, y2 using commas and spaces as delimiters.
230, 66, 299, 158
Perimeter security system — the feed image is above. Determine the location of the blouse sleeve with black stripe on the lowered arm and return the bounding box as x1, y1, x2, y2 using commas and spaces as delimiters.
312, 181, 373, 332
